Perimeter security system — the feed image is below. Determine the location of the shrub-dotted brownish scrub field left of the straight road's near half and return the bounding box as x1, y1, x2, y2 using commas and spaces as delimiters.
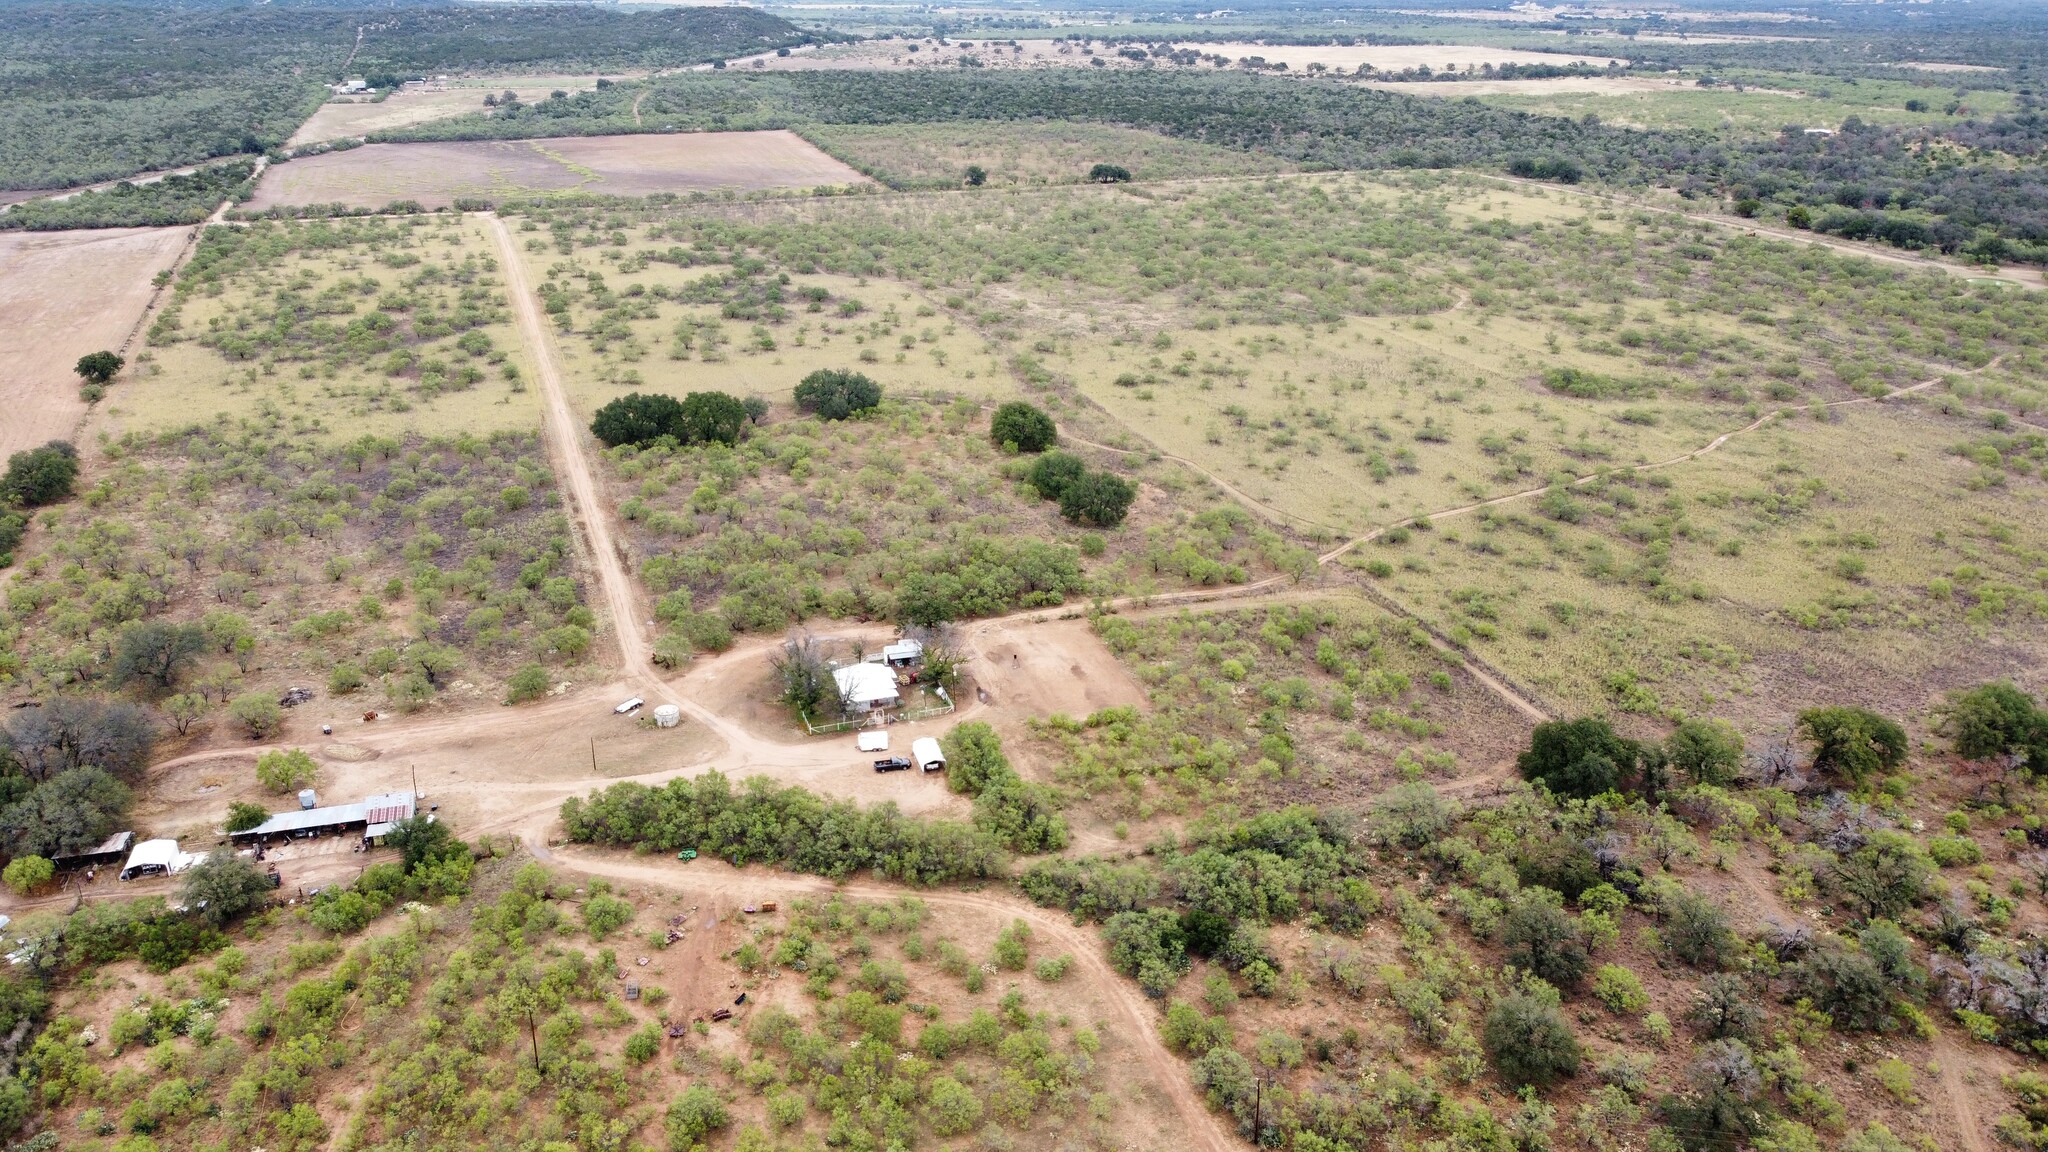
0, 416, 596, 709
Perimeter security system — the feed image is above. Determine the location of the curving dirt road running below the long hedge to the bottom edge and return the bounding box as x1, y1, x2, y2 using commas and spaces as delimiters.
526, 840, 1228, 1152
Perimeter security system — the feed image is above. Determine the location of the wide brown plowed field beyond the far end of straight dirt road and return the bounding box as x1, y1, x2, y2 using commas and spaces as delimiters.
250, 131, 866, 211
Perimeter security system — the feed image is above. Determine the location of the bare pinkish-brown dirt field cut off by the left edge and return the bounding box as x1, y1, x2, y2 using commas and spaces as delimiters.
0, 228, 190, 457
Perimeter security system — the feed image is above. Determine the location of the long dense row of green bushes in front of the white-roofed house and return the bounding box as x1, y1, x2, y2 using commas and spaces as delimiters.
561, 773, 1008, 883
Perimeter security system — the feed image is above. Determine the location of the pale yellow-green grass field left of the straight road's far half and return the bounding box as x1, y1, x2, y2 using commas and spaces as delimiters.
116, 215, 541, 441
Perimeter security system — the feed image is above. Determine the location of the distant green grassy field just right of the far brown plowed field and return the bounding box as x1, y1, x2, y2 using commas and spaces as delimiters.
805, 123, 1290, 189
